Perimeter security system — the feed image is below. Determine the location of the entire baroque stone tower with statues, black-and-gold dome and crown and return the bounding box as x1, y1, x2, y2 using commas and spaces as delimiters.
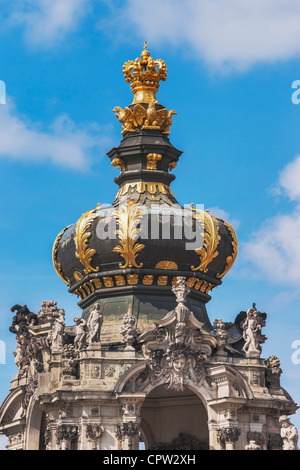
0, 44, 298, 450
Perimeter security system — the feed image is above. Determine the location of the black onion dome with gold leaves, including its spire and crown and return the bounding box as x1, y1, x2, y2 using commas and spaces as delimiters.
53, 46, 238, 341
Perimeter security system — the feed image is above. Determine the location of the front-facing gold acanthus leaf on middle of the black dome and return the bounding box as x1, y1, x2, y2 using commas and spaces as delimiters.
113, 199, 145, 269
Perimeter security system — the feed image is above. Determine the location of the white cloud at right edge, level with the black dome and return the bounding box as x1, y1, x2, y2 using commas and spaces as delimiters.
241, 156, 300, 286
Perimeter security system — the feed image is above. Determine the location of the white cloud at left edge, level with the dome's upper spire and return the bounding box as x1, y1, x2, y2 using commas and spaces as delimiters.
0, 99, 110, 169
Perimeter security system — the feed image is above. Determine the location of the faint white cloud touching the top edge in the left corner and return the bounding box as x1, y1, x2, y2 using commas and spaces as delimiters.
8, 0, 90, 47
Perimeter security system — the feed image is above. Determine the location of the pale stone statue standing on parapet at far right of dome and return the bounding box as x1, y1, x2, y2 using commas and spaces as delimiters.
242, 304, 267, 357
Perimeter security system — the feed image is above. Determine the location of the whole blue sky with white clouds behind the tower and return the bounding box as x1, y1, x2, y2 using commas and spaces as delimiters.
0, 0, 300, 448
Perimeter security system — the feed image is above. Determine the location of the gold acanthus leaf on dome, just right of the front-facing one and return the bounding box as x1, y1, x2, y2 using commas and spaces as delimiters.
191, 205, 221, 273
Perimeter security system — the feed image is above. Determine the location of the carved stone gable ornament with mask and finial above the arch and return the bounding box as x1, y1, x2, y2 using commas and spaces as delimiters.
126, 276, 217, 391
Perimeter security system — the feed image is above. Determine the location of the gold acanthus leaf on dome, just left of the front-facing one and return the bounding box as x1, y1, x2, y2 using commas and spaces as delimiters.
74, 207, 99, 274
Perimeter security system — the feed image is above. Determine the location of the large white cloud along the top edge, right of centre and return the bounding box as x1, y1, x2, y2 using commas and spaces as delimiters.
108, 0, 300, 70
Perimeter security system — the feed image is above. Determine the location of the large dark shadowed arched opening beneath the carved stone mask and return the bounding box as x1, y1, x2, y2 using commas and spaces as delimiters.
141, 385, 209, 450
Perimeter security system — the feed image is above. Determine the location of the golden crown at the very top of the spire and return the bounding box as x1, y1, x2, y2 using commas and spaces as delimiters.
123, 42, 168, 103
